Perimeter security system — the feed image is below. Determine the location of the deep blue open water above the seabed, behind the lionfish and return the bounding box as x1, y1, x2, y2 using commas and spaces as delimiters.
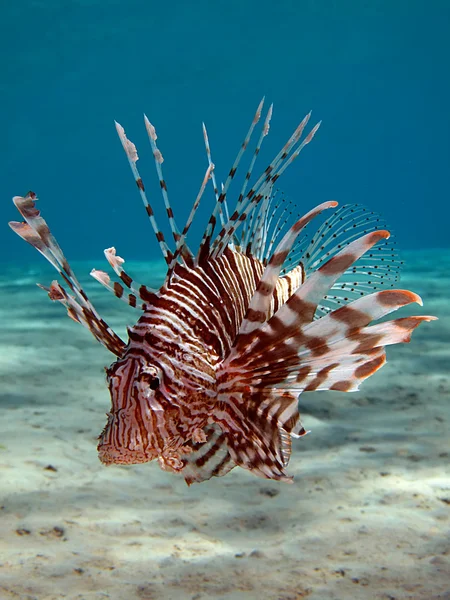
0, 0, 450, 267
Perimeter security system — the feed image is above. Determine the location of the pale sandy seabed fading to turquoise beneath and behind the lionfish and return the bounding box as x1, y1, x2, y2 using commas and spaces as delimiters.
0, 251, 450, 600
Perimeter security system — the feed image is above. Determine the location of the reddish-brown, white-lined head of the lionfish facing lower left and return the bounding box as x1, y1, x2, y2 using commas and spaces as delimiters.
98, 354, 216, 472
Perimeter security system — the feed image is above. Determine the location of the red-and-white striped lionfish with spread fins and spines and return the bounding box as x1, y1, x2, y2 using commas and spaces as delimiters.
10, 100, 434, 484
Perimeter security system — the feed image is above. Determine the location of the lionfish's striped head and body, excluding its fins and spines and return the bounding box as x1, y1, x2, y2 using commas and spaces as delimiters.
98, 248, 302, 471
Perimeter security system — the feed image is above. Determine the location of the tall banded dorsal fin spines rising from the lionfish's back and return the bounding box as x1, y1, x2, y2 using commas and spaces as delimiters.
116, 99, 320, 270
